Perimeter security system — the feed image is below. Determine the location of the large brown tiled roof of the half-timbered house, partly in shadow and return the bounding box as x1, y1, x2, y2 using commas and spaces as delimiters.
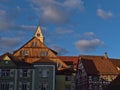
80, 55, 119, 74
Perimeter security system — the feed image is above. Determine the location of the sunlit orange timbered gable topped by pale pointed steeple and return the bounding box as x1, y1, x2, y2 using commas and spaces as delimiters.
13, 27, 68, 69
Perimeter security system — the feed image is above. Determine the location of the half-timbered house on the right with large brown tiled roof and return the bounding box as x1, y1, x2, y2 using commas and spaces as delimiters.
76, 55, 119, 90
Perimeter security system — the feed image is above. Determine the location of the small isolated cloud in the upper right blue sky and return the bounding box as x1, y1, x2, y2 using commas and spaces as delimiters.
97, 9, 113, 19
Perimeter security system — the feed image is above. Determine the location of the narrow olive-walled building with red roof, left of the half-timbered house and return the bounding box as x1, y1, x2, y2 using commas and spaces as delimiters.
56, 56, 79, 90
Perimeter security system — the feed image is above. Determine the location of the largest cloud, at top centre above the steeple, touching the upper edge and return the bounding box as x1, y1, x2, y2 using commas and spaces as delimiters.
32, 0, 84, 24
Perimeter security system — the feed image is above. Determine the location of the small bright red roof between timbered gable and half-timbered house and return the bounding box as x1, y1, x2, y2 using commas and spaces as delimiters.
58, 56, 79, 69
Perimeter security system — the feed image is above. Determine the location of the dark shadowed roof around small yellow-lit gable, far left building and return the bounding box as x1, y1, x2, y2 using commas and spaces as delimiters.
0, 53, 32, 68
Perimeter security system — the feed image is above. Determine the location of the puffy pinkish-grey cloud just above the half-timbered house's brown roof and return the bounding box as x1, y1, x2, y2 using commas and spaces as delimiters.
75, 32, 105, 52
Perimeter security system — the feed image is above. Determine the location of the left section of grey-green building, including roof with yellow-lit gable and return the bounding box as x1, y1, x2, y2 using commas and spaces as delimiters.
0, 53, 33, 90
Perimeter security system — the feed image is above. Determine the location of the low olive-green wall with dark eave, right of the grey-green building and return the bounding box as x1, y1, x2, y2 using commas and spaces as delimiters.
56, 69, 75, 90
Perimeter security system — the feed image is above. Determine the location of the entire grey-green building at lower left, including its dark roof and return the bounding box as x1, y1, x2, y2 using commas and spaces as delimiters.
0, 53, 56, 90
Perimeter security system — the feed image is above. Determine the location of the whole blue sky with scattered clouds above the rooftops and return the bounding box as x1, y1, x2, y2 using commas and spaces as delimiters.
0, 0, 120, 58
